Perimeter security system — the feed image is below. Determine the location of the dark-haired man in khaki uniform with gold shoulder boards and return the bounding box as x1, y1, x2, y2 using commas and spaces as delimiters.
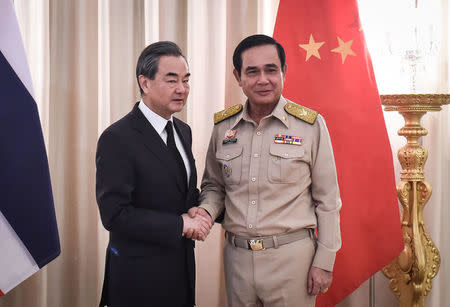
190, 35, 341, 306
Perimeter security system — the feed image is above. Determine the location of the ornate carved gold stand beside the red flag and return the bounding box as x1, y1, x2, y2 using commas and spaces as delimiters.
381, 94, 450, 307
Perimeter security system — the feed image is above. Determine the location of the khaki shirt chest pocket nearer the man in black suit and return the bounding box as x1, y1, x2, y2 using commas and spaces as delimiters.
216, 145, 242, 185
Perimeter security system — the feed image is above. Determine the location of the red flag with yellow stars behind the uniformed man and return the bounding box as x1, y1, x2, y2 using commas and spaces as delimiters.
274, 0, 403, 306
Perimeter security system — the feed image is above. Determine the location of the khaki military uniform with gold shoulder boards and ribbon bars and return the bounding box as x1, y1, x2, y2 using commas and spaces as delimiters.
201, 97, 341, 306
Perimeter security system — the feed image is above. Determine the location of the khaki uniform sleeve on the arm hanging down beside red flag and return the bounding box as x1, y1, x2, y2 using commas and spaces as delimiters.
311, 115, 342, 271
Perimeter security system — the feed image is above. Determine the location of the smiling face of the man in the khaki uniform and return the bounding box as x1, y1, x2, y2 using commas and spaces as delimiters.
234, 45, 284, 105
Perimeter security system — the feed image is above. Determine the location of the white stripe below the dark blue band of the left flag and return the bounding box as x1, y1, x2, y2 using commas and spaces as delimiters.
0, 212, 39, 294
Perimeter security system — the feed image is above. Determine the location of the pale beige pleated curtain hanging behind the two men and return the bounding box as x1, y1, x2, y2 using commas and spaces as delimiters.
0, 0, 450, 307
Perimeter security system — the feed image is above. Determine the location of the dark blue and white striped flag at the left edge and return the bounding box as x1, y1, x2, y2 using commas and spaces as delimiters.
0, 0, 60, 296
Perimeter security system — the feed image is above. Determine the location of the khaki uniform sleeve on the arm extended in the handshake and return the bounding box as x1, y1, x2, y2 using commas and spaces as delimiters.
200, 126, 225, 220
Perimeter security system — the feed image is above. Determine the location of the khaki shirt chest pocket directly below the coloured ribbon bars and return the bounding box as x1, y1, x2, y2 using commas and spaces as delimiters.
267, 144, 306, 183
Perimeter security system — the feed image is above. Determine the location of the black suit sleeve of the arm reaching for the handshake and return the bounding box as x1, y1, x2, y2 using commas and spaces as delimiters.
96, 131, 183, 247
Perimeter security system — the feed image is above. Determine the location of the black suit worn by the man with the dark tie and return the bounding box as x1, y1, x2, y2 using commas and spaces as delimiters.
96, 103, 198, 307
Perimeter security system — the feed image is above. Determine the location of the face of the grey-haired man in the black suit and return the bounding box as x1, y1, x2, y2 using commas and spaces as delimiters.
139, 56, 190, 119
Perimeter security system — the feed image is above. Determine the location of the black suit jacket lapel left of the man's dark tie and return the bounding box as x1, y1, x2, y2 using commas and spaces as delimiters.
131, 103, 186, 192
